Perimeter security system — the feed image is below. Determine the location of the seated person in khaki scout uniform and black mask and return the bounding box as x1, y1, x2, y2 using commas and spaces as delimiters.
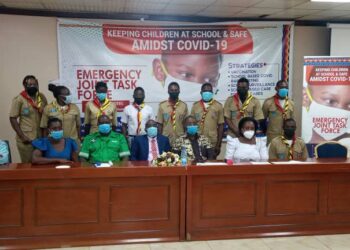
269, 118, 307, 161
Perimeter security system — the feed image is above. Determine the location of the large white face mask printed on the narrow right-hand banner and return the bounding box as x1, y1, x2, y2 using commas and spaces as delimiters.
308, 101, 350, 141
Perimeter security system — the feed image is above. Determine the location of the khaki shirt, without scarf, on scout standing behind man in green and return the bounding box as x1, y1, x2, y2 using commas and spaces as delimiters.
84, 101, 117, 134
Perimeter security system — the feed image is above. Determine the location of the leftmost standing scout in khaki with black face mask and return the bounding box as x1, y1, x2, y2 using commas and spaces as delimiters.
10, 75, 47, 163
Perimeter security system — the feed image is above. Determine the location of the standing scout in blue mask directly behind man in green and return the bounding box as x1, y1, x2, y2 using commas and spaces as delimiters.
84, 82, 117, 135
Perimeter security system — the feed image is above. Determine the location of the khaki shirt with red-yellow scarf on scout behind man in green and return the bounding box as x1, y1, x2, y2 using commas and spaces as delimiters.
84, 98, 117, 134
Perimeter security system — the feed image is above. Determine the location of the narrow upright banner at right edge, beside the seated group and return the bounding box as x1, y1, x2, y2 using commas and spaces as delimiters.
302, 56, 350, 149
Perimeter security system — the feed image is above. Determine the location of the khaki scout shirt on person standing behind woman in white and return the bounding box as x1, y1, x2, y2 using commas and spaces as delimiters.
224, 96, 264, 137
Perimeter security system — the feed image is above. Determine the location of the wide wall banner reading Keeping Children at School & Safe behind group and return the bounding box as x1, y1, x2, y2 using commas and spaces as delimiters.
58, 19, 292, 118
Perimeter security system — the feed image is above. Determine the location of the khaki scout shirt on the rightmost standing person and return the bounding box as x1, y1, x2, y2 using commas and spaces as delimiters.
262, 96, 294, 144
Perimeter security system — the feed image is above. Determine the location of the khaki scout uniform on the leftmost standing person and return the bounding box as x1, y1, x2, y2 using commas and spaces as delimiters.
10, 91, 47, 163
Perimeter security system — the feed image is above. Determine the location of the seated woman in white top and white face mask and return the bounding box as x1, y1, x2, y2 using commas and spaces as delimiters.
225, 117, 268, 162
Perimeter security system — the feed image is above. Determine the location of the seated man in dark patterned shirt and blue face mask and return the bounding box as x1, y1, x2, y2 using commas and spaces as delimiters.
173, 115, 215, 162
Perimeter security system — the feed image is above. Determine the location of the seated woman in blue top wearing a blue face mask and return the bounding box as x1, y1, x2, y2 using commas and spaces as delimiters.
32, 117, 78, 164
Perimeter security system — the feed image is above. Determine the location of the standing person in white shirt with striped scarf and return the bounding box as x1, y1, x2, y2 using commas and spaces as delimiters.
122, 87, 154, 147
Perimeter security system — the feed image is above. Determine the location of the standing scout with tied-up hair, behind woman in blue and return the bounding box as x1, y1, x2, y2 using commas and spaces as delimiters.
40, 84, 81, 145
